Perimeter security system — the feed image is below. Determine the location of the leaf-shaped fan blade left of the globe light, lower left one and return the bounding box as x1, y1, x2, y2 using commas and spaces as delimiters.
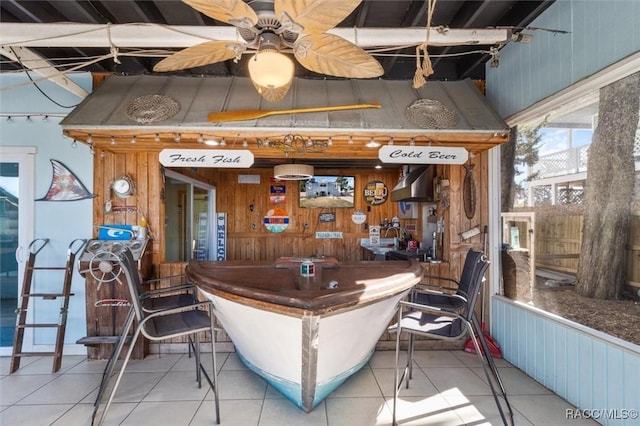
153, 41, 244, 72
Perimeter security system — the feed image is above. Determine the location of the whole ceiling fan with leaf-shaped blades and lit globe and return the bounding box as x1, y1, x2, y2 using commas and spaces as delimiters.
153, 0, 384, 102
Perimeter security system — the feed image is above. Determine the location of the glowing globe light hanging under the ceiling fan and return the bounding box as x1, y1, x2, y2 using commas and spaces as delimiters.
249, 33, 295, 102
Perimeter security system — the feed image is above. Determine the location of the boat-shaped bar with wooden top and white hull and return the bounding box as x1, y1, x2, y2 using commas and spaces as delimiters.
188, 262, 422, 412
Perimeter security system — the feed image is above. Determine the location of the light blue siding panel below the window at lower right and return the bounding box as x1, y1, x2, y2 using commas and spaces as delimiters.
491, 296, 640, 426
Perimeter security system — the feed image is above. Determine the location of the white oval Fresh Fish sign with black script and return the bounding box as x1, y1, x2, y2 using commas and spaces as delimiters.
160, 149, 253, 169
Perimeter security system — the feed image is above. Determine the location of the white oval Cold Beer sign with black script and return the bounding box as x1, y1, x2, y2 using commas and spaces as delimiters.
378, 145, 469, 164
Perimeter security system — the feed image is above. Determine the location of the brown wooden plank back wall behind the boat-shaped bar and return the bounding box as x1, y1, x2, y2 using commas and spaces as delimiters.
214, 169, 404, 260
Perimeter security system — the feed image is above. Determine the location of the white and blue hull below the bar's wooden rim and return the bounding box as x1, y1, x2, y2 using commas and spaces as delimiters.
198, 290, 409, 411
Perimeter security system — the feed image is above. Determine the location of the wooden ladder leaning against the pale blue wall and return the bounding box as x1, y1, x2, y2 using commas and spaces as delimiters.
9, 238, 87, 373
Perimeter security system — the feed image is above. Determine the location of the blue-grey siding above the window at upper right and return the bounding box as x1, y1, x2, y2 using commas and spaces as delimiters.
486, 0, 640, 117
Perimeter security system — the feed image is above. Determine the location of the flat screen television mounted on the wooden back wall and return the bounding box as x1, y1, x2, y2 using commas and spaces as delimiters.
300, 176, 355, 208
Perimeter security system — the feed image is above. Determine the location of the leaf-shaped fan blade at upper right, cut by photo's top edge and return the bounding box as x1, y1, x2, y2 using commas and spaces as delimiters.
274, 0, 362, 34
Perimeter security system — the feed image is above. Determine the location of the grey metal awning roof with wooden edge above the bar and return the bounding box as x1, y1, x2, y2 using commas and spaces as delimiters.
61, 75, 509, 159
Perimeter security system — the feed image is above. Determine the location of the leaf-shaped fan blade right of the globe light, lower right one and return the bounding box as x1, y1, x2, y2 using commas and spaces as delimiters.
294, 34, 384, 78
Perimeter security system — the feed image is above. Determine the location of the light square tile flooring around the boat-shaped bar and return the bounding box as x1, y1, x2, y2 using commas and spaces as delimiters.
0, 351, 596, 426
